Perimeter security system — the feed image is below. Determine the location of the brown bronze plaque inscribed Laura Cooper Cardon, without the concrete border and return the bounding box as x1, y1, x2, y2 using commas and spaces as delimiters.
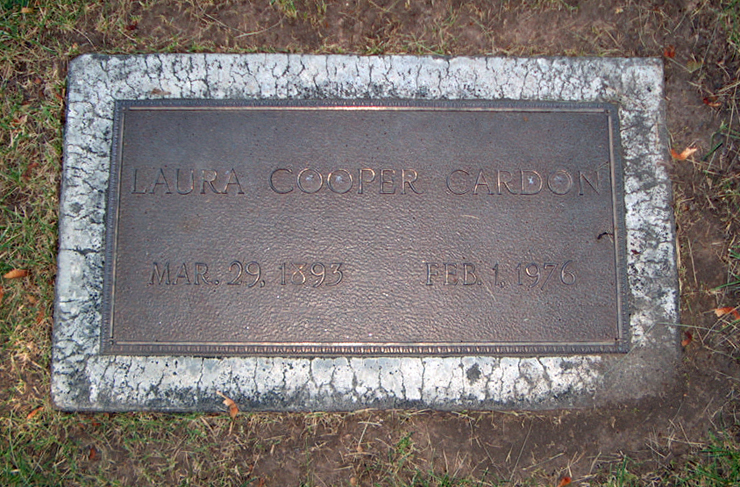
102, 100, 628, 356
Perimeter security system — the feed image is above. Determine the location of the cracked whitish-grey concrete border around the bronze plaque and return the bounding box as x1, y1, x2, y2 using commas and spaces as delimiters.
52, 54, 678, 411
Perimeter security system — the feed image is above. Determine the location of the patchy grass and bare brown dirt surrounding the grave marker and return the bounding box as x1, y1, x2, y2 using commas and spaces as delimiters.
0, 0, 740, 487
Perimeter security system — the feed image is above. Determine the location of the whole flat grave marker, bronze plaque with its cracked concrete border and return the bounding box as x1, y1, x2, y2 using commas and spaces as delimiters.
52, 54, 678, 411
